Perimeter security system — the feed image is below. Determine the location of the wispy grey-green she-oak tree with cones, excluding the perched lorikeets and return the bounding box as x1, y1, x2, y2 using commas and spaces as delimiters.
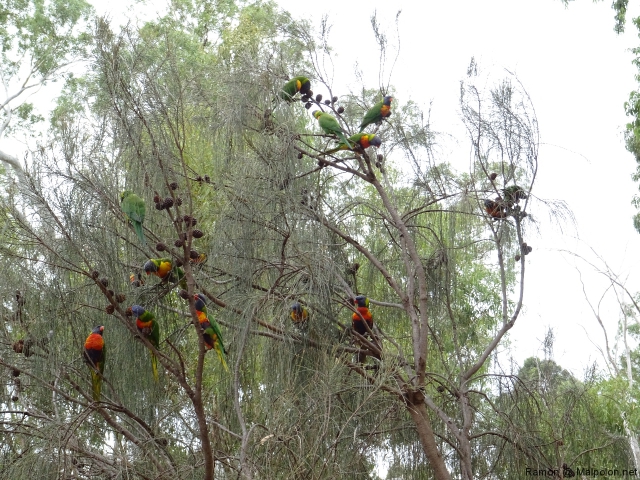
0, 1, 632, 479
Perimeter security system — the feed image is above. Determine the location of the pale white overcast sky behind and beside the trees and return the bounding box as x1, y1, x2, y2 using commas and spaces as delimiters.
81, 0, 640, 376
